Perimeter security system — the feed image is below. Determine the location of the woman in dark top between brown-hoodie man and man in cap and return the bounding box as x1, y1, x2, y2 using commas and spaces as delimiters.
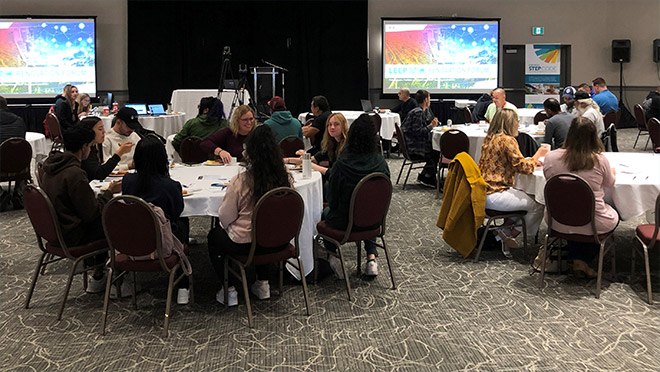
79, 116, 134, 180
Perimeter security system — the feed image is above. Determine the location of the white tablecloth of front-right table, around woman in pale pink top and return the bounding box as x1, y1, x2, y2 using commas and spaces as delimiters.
514, 152, 660, 221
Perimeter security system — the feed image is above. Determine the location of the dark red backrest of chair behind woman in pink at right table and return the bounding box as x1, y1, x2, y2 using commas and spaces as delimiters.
543, 173, 598, 241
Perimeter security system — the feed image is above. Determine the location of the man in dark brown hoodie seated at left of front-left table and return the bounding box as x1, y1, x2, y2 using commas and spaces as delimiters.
41, 126, 121, 293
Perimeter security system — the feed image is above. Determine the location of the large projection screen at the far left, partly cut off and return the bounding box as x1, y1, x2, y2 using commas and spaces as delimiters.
0, 17, 96, 98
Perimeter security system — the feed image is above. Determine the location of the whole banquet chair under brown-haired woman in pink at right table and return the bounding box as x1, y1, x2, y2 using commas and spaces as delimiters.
539, 173, 616, 298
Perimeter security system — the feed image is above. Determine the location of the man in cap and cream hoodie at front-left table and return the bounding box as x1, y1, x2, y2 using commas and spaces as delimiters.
103, 107, 142, 170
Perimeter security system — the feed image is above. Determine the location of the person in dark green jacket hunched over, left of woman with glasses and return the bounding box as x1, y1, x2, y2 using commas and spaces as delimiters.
172, 97, 229, 152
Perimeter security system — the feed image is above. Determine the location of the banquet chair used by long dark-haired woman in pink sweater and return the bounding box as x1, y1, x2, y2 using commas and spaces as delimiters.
223, 187, 310, 327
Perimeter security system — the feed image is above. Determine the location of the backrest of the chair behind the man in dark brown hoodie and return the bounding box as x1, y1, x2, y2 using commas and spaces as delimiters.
23, 184, 66, 250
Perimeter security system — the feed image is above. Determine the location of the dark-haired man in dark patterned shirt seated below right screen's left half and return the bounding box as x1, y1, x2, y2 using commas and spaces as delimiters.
401, 89, 440, 187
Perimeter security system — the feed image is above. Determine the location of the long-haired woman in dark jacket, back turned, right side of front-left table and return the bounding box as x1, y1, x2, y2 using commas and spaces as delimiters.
322, 114, 390, 279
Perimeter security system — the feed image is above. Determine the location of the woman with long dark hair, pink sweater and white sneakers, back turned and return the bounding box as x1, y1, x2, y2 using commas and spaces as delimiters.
208, 125, 293, 306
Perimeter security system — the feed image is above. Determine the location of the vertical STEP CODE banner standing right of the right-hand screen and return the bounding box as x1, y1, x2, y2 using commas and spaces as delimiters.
525, 44, 561, 108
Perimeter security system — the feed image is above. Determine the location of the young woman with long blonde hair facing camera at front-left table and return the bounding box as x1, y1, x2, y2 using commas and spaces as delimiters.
284, 112, 348, 176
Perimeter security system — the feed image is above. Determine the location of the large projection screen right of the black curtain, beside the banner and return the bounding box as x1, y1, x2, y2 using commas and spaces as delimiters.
382, 18, 500, 94
